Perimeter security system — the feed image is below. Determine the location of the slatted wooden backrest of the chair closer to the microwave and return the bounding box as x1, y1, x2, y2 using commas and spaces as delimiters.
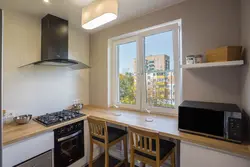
129, 127, 160, 158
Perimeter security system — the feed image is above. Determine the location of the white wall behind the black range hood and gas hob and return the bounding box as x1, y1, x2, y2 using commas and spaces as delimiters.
3, 11, 89, 115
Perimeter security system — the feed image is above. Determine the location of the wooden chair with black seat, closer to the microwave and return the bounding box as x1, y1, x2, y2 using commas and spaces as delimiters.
129, 127, 175, 167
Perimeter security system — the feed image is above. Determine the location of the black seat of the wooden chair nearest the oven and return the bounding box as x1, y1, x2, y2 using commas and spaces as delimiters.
92, 126, 127, 143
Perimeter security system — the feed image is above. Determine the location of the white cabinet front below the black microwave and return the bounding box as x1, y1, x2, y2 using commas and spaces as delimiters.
180, 142, 250, 167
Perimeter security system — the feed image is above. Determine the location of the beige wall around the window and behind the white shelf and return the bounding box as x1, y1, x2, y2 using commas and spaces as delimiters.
90, 0, 241, 106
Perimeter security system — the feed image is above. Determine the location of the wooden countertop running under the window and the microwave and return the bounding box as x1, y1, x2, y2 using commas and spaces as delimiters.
83, 107, 250, 157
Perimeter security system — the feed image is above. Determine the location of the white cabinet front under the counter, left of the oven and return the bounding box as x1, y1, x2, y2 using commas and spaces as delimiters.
3, 132, 54, 167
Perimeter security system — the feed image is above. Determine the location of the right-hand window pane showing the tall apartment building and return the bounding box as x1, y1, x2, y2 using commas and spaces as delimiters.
144, 31, 175, 108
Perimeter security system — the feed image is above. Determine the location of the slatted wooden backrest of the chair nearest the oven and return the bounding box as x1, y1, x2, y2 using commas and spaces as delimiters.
88, 117, 108, 141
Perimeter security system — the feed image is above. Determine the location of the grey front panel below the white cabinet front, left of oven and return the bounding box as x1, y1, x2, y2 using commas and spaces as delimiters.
16, 151, 52, 167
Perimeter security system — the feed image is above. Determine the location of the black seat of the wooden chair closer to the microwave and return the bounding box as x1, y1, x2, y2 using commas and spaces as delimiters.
135, 139, 175, 161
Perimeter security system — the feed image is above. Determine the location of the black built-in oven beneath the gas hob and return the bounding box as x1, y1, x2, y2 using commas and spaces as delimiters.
54, 121, 84, 167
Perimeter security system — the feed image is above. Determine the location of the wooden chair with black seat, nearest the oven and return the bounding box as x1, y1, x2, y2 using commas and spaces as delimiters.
88, 117, 128, 167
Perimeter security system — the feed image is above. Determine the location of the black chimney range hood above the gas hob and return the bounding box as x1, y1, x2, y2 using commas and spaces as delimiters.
21, 14, 90, 70
